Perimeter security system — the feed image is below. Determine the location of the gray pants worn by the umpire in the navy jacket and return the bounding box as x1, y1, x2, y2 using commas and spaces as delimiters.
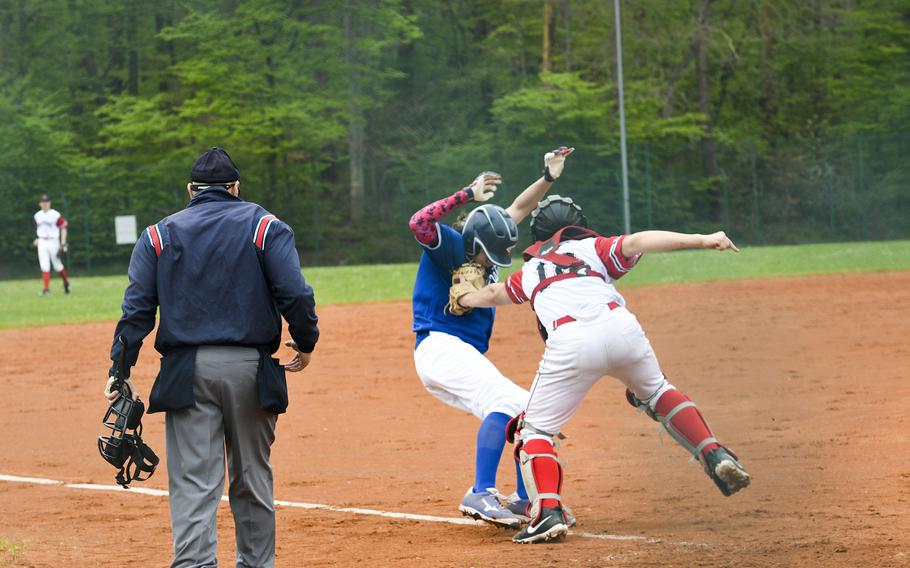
165, 346, 276, 568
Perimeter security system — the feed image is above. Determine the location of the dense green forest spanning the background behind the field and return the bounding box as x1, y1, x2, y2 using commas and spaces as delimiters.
0, 0, 910, 276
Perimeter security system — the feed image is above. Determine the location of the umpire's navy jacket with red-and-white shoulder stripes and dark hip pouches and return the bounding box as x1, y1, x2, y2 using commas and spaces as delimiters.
111, 186, 319, 414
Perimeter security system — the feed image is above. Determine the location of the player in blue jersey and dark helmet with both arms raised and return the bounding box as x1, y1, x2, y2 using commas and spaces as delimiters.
409, 147, 574, 528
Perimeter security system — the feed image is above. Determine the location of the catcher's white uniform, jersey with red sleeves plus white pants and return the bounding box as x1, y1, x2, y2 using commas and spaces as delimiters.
506, 236, 672, 435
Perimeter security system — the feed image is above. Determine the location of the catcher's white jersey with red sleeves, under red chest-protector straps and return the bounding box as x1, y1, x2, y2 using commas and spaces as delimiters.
506, 235, 641, 327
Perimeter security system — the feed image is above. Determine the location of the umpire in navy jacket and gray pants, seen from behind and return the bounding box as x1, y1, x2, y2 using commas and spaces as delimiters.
105, 148, 319, 568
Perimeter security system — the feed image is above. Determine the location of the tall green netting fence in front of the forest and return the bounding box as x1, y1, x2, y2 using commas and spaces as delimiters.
0, 133, 910, 275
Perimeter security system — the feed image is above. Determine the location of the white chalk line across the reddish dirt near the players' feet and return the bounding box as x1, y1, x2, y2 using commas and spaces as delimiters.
0, 473, 664, 544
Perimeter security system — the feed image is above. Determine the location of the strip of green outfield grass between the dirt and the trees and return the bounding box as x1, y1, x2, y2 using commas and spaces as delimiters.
0, 241, 910, 329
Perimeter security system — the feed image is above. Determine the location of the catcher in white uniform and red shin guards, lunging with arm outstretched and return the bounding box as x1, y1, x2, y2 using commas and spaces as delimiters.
458, 195, 751, 543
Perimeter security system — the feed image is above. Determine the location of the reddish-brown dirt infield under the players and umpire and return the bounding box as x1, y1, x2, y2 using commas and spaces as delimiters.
0, 272, 910, 567
